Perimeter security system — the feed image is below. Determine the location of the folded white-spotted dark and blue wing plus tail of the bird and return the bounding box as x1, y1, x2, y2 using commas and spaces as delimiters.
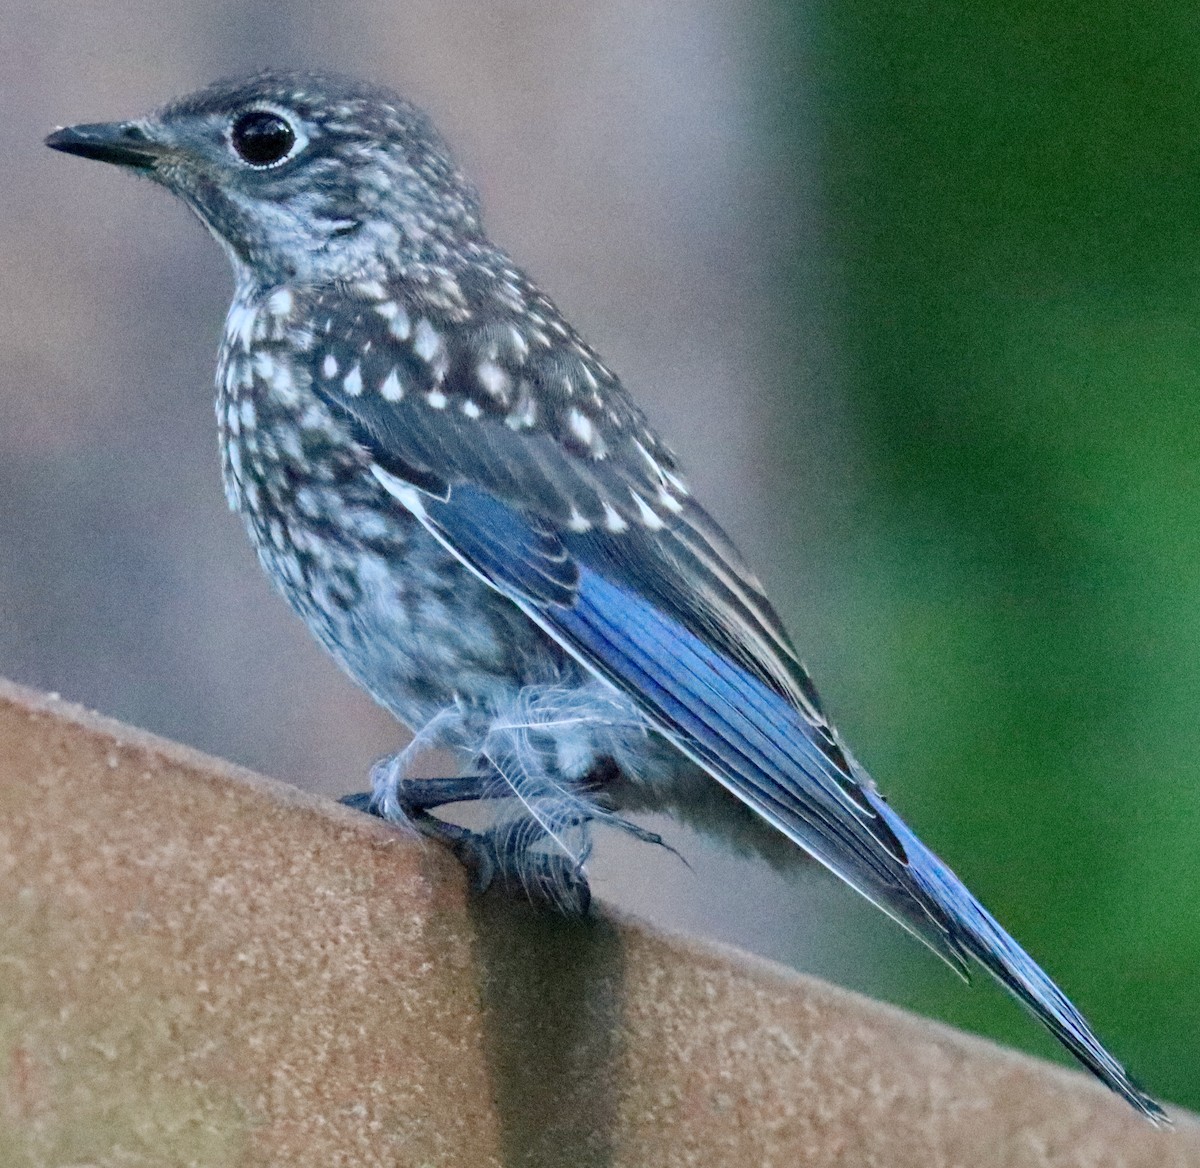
297, 284, 1160, 1118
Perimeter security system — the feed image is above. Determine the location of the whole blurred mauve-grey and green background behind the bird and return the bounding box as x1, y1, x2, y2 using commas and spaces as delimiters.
0, 0, 1200, 1107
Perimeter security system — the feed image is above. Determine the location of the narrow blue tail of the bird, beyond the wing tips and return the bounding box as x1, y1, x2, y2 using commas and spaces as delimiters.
868, 791, 1170, 1125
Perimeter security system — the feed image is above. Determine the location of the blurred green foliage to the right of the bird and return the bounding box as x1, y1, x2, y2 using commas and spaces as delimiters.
774, 0, 1200, 1108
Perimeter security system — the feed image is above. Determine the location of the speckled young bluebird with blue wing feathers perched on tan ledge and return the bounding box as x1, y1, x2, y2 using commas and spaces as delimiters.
46, 70, 1168, 1124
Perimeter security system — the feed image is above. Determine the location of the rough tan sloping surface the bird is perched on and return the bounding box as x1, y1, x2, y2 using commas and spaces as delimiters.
0, 684, 1200, 1168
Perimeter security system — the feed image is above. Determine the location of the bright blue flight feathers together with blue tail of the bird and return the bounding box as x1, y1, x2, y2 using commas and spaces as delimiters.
428, 475, 1163, 1121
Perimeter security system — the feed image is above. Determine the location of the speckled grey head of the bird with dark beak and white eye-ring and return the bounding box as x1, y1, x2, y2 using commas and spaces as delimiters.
46, 72, 480, 286
